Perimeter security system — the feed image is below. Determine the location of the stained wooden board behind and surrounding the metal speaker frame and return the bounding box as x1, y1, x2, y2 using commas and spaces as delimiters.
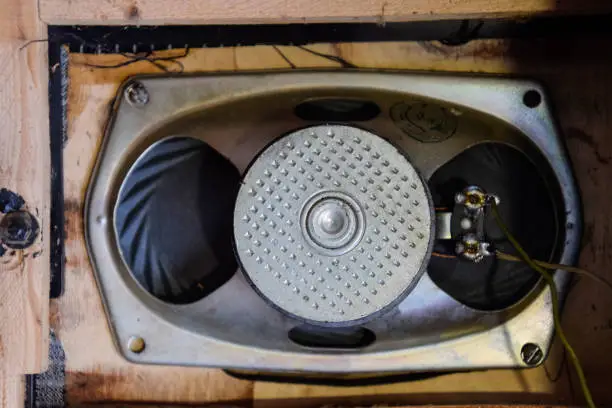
57, 40, 612, 407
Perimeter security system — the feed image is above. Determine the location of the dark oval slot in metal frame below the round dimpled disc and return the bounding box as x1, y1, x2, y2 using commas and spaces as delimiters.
288, 324, 376, 349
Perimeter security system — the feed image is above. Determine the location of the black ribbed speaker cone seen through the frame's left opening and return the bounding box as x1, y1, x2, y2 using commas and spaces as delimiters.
115, 138, 240, 303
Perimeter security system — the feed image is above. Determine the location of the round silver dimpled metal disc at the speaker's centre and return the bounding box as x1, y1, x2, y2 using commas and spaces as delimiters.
234, 125, 433, 325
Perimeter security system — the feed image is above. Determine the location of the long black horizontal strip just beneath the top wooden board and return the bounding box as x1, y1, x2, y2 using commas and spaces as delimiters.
49, 13, 612, 53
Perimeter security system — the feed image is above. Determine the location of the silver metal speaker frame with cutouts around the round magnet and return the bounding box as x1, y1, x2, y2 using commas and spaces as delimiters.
85, 70, 581, 373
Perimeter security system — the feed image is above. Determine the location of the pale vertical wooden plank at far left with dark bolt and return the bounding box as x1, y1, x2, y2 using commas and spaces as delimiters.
0, 0, 51, 376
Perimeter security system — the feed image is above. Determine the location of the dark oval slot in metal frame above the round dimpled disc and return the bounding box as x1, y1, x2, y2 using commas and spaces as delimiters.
295, 98, 380, 122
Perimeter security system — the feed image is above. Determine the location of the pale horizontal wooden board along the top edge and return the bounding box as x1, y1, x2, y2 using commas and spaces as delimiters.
40, 0, 612, 25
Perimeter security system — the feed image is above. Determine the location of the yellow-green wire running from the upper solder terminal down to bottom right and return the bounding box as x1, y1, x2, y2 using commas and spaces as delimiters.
491, 200, 597, 408
